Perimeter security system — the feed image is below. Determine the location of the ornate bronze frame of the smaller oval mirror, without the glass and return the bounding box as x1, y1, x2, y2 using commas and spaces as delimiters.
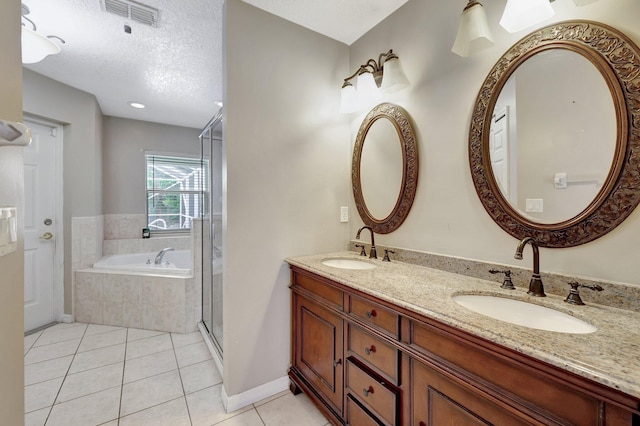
351, 103, 418, 234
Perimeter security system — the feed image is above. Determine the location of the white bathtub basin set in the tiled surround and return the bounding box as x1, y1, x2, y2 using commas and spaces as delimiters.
93, 250, 193, 276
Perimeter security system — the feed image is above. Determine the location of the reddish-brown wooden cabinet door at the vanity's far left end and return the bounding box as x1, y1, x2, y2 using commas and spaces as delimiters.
295, 296, 344, 414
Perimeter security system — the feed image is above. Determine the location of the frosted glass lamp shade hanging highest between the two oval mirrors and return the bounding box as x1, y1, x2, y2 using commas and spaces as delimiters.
451, 1, 493, 57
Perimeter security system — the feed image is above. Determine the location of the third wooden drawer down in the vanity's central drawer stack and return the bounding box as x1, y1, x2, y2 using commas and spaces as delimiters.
347, 360, 398, 425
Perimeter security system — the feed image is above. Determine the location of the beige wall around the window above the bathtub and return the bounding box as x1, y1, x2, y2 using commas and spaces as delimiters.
102, 116, 200, 214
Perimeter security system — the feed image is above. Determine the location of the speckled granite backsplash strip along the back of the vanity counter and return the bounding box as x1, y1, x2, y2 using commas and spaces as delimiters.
350, 240, 640, 312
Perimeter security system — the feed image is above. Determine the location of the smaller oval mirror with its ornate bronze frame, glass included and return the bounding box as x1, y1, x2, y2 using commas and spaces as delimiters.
351, 103, 418, 234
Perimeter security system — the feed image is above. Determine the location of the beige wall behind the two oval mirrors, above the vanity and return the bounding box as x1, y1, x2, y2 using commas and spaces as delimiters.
349, 0, 640, 285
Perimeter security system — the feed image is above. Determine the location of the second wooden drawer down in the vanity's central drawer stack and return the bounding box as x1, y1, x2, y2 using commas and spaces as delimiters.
348, 324, 398, 385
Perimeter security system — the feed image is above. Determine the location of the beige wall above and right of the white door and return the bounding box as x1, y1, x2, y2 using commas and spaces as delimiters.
23, 69, 102, 313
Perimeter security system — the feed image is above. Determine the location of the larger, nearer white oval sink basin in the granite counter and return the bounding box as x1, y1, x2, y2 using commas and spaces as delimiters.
453, 295, 597, 334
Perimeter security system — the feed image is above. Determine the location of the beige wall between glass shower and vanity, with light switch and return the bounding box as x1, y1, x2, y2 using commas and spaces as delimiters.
223, 0, 350, 396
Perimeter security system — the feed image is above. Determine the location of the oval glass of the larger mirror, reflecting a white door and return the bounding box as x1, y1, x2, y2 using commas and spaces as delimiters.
489, 49, 617, 224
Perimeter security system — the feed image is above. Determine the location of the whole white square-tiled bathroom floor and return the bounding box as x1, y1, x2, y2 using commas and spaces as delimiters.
24, 323, 328, 426
